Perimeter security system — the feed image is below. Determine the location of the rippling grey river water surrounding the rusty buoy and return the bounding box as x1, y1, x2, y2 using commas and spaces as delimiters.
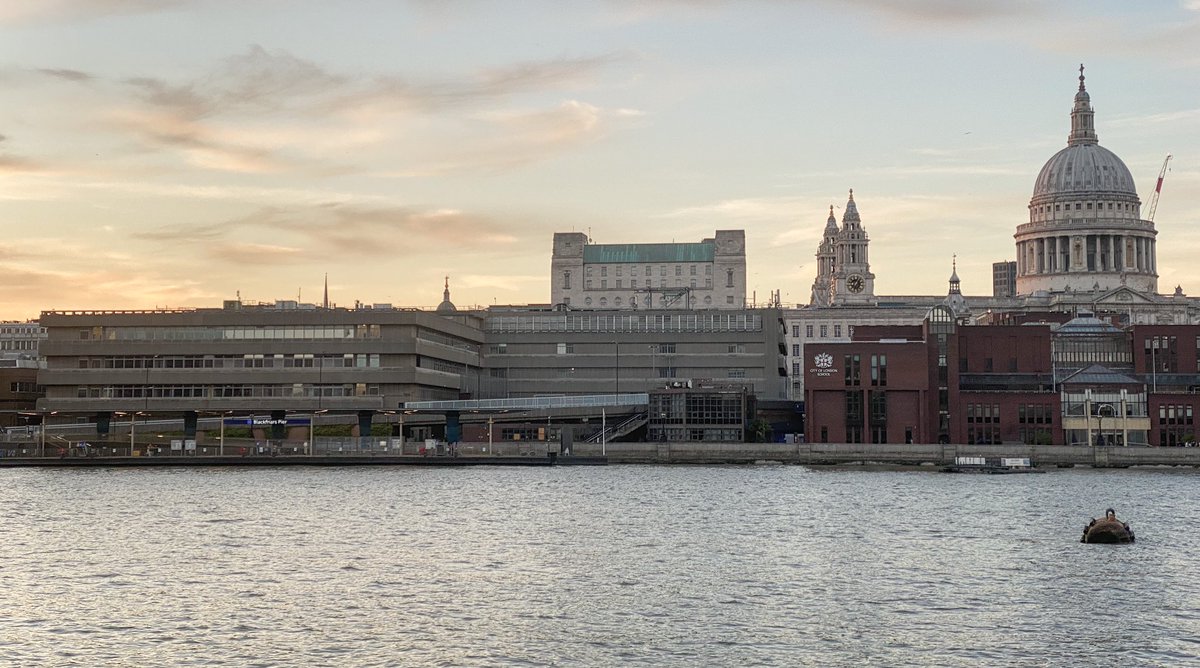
0, 465, 1200, 667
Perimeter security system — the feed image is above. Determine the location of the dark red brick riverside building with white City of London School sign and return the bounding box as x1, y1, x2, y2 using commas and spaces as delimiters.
805, 306, 1200, 446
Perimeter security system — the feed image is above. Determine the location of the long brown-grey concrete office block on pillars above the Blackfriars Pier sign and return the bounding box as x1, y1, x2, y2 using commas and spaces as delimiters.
37, 301, 484, 433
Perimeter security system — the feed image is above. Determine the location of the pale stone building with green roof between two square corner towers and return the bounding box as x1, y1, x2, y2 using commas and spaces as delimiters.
550, 230, 746, 309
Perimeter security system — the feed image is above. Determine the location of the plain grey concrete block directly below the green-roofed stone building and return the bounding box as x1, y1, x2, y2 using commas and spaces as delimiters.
482, 307, 787, 399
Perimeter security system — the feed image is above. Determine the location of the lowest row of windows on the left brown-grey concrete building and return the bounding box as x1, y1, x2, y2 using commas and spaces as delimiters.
77, 383, 380, 399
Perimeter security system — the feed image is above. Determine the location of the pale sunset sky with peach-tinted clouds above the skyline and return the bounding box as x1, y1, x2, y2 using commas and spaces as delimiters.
0, 0, 1200, 320
